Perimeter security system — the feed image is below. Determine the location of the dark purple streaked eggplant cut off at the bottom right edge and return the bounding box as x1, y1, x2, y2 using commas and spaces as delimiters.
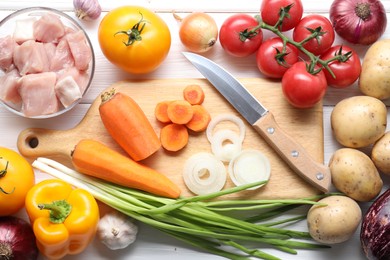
360, 189, 390, 260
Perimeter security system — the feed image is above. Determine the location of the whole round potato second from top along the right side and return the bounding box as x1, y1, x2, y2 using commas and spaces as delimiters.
330, 96, 387, 148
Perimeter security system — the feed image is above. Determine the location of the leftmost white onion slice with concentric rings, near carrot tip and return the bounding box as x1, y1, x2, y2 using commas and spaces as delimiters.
183, 152, 227, 195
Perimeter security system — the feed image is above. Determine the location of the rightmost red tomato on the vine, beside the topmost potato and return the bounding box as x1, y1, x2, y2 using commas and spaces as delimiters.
320, 45, 362, 88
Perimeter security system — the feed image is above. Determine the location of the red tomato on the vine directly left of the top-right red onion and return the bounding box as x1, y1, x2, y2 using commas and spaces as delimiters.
293, 14, 335, 55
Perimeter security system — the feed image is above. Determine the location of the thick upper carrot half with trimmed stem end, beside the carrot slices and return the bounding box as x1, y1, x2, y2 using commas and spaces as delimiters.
99, 90, 161, 161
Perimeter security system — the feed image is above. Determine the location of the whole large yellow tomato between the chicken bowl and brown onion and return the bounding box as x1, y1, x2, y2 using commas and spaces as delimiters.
98, 6, 171, 74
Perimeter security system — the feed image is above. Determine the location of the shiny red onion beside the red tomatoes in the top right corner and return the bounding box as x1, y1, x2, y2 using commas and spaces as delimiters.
330, 0, 387, 45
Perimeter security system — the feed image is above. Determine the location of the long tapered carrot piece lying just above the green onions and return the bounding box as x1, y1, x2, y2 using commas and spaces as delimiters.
72, 139, 180, 198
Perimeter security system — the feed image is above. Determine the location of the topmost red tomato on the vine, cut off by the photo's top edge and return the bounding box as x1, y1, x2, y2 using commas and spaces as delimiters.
260, 0, 303, 32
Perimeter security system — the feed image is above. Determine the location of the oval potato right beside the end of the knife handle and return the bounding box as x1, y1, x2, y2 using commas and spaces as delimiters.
329, 148, 383, 201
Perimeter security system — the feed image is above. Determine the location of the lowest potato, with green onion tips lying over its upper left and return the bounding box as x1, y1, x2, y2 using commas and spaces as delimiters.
307, 196, 362, 244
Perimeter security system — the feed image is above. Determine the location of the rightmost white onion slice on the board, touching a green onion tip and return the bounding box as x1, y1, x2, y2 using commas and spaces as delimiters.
228, 150, 271, 190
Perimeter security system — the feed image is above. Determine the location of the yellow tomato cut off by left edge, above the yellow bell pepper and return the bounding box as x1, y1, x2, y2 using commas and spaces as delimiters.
0, 147, 35, 216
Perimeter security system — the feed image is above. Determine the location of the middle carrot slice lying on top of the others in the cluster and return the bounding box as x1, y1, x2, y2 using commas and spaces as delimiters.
167, 100, 194, 124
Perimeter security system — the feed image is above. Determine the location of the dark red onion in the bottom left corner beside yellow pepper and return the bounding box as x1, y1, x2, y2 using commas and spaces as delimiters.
0, 216, 39, 260
